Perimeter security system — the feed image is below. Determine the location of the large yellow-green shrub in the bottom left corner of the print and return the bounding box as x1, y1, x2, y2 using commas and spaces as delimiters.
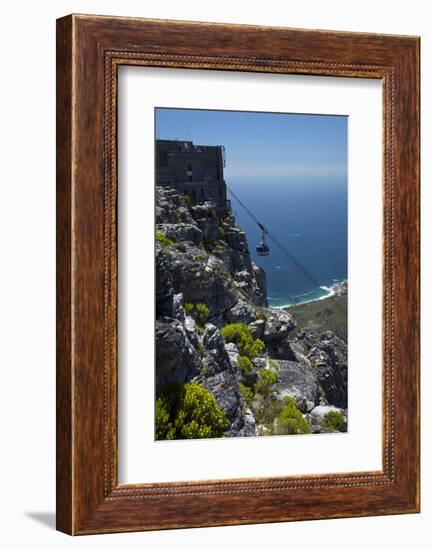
156, 382, 229, 440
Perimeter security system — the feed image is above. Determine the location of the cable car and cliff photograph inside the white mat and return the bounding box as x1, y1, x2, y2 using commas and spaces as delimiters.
154, 107, 348, 441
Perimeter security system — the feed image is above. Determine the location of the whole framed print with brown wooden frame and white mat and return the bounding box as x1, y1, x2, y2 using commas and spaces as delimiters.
57, 15, 419, 534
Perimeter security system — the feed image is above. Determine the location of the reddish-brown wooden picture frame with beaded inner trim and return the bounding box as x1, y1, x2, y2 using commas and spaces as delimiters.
57, 15, 419, 535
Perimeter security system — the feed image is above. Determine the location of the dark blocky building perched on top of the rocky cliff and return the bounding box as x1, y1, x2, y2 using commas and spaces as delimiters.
156, 139, 229, 207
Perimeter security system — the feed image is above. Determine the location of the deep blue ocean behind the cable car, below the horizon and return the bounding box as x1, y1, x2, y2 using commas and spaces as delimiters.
227, 178, 348, 307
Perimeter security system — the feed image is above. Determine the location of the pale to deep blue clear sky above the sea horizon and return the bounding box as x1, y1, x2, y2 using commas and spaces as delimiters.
156, 108, 348, 185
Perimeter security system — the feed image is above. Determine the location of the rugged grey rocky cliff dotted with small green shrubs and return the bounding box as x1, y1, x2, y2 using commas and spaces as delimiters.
156, 186, 347, 436
